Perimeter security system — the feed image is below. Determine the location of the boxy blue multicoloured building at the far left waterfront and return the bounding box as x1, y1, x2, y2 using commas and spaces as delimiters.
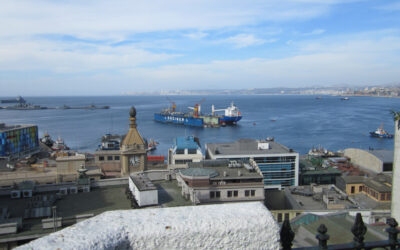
0, 123, 39, 159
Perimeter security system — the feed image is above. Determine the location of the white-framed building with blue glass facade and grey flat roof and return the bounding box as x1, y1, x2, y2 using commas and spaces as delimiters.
205, 139, 299, 189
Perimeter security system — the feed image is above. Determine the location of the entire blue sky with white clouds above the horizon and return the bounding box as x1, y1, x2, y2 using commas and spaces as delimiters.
0, 0, 400, 96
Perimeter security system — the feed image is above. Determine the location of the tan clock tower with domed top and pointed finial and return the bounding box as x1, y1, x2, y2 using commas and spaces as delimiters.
120, 107, 147, 176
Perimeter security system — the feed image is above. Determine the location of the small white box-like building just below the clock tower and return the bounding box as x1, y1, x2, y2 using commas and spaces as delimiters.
129, 173, 158, 207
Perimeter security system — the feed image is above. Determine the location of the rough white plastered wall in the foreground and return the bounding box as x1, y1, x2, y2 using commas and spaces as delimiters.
18, 202, 279, 249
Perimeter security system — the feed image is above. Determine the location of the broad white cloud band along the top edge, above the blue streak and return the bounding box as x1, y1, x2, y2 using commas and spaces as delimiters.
0, 0, 346, 38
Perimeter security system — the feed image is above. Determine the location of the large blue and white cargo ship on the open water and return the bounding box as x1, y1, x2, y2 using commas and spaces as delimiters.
154, 102, 242, 127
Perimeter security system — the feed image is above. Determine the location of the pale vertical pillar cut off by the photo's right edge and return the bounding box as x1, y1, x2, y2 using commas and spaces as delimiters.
392, 120, 400, 222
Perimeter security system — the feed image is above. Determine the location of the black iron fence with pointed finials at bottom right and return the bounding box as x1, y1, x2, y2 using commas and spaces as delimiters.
280, 213, 400, 250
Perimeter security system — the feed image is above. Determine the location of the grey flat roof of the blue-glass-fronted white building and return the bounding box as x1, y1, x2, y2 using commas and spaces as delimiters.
206, 139, 295, 156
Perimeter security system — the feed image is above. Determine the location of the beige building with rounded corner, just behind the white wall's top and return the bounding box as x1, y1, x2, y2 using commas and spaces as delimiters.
176, 160, 265, 204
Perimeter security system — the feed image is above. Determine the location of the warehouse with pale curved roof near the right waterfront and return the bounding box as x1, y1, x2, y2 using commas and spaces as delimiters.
344, 148, 393, 173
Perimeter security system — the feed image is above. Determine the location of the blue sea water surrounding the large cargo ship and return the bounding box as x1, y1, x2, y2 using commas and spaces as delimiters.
0, 95, 400, 155
